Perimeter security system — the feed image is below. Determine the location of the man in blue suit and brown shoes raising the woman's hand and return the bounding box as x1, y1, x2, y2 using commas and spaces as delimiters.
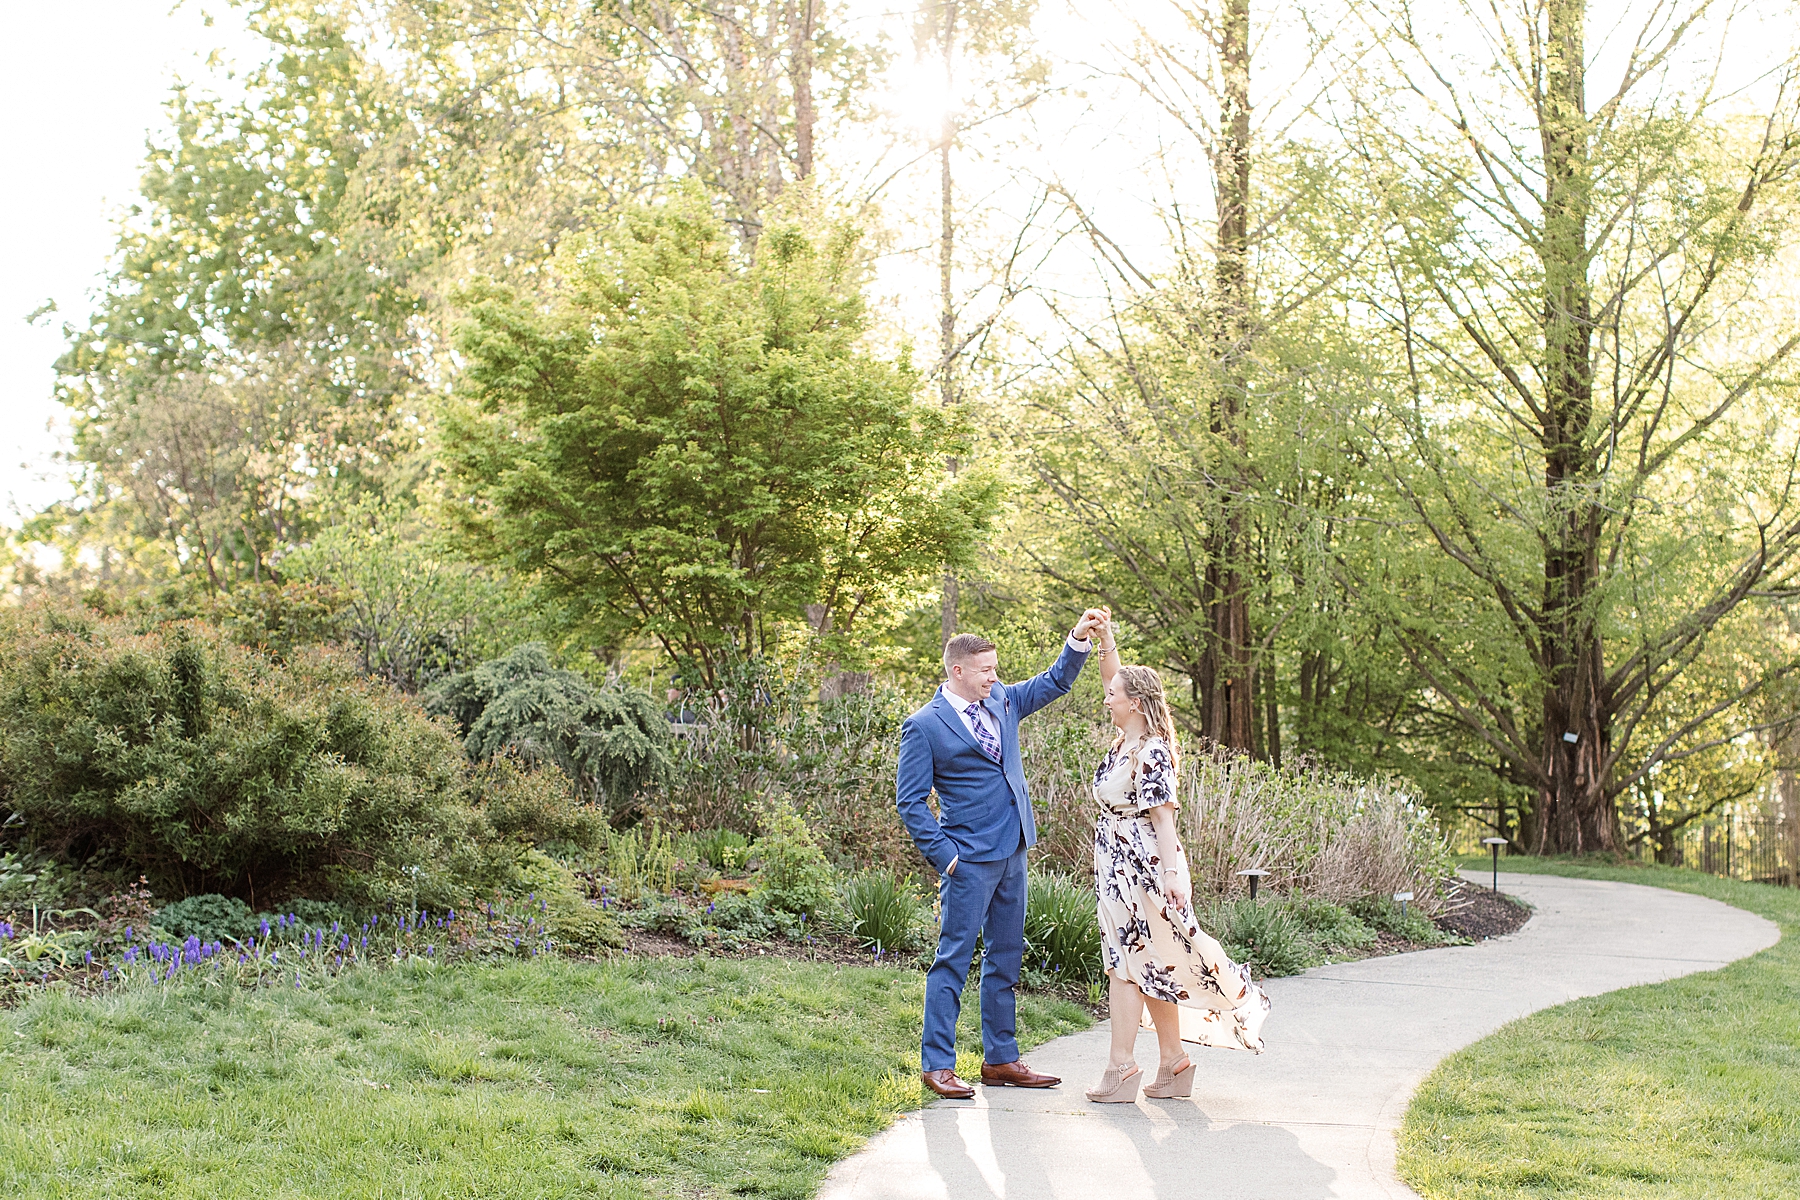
896, 608, 1107, 1099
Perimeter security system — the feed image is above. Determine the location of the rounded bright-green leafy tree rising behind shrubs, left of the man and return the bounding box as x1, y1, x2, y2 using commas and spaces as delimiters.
450, 191, 994, 684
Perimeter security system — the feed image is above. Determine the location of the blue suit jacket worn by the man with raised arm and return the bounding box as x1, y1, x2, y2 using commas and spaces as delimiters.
895, 642, 1087, 874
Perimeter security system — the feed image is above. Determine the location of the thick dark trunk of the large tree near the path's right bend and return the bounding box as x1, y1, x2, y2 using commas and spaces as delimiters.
1534, 0, 1618, 853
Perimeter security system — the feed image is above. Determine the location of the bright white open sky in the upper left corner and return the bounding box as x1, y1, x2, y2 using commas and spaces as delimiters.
0, 0, 261, 525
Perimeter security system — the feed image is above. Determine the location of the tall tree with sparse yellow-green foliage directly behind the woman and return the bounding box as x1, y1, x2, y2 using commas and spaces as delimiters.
1035, 0, 1368, 756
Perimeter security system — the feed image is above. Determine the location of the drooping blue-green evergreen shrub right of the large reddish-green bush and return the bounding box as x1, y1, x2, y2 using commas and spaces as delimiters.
425, 642, 671, 810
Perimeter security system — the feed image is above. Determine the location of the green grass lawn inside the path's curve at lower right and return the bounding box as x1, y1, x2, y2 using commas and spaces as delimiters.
1400, 858, 1800, 1200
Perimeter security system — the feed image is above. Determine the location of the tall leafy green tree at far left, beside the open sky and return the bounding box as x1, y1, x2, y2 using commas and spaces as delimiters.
32, 4, 426, 588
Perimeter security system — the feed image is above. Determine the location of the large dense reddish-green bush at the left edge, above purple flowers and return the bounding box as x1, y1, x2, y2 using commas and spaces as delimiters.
0, 606, 511, 905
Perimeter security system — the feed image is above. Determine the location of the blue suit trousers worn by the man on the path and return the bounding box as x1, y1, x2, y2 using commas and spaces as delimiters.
920, 838, 1024, 1070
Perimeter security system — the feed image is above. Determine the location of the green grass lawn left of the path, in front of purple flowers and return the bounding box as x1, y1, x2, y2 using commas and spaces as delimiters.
0, 959, 1089, 1200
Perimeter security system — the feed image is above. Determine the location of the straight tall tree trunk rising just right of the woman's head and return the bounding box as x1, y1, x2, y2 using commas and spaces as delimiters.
1201, 0, 1256, 750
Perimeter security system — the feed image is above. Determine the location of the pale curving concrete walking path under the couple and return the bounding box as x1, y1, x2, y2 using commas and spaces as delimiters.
819, 873, 1780, 1200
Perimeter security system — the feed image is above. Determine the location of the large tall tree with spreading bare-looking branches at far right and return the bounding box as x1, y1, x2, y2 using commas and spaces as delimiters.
1352, 0, 1800, 853
